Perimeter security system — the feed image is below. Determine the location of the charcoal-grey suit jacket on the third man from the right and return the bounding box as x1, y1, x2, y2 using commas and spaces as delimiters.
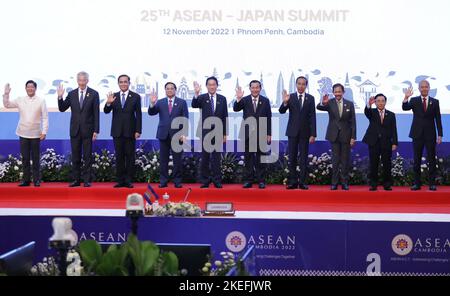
317, 98, 356, 143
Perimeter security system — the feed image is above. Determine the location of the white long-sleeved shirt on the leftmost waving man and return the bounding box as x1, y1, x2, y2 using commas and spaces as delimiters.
3, 95, 48, 139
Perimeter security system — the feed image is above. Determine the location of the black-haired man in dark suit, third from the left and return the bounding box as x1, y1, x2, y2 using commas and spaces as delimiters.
103, 75, 142, 188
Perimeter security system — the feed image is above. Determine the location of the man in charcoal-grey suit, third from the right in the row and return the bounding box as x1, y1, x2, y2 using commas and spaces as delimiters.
317, 83, 356, 190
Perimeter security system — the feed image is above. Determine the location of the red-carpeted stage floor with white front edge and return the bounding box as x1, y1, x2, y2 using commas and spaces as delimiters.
0, 183, 450, 221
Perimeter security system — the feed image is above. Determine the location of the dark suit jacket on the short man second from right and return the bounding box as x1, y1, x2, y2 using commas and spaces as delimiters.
363, 106, 398, 148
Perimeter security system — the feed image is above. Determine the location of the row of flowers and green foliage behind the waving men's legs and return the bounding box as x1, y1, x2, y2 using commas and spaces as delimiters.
0, 147, 450, 186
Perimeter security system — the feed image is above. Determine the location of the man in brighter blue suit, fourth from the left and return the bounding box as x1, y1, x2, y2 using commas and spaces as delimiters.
148, 82, 189, 188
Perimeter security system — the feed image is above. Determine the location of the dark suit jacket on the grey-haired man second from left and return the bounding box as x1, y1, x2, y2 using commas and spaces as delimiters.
58, 87, 100, 138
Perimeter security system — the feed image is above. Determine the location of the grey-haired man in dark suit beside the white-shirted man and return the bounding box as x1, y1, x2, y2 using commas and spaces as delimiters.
57, 72, 100, 187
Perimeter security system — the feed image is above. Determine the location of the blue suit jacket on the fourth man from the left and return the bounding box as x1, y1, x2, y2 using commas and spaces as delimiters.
148, 97, 189, 140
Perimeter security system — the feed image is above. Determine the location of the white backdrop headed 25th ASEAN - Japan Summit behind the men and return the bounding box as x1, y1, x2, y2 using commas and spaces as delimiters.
0, 0, 450, 113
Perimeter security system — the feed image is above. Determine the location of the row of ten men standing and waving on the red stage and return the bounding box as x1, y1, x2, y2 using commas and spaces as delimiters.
3, 72, 443, 191
